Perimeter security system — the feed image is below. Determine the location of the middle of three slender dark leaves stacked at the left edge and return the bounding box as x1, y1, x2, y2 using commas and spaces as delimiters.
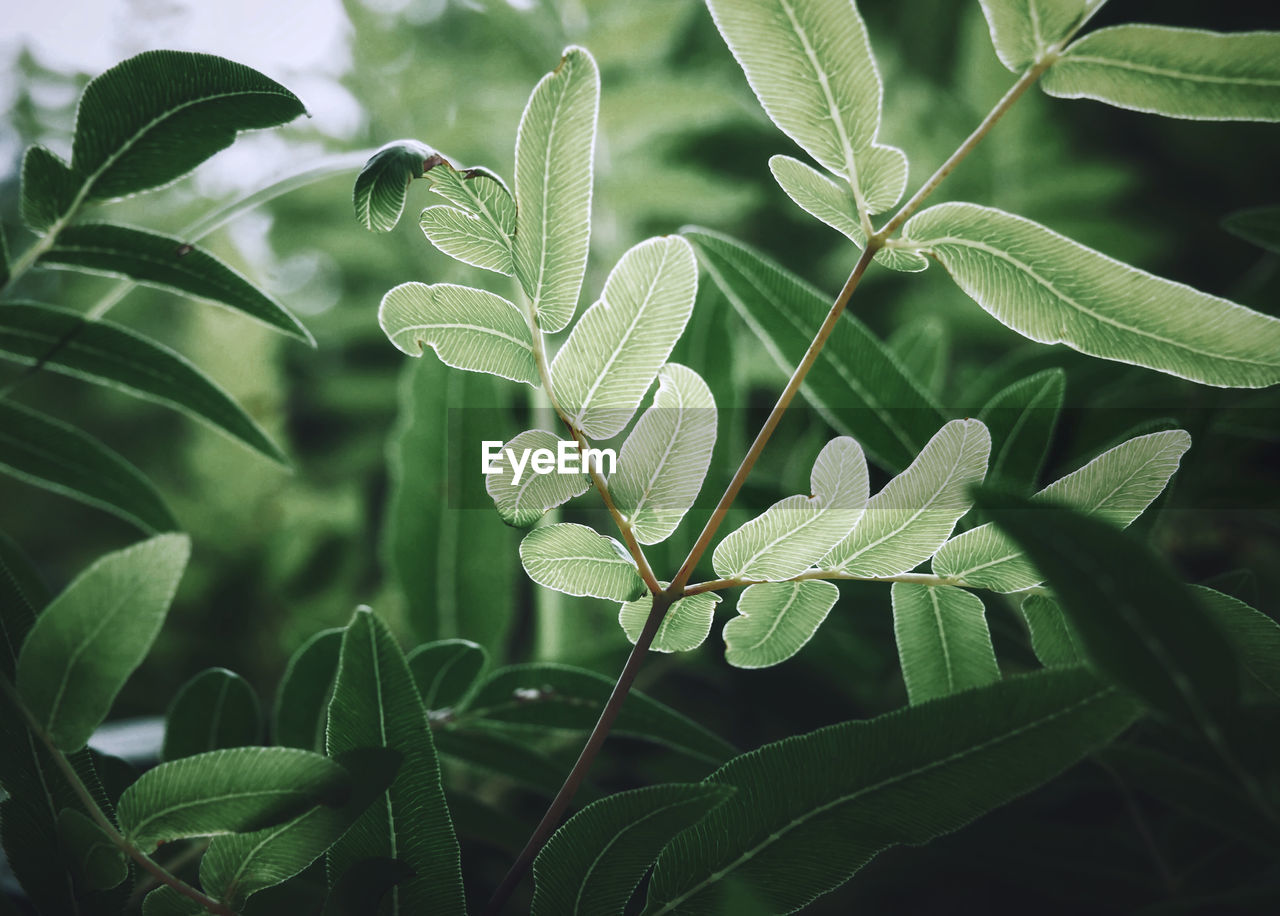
0, 302, 288, 464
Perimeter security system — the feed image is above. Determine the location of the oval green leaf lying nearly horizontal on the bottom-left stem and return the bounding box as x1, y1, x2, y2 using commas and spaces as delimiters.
118, 747, 349, 849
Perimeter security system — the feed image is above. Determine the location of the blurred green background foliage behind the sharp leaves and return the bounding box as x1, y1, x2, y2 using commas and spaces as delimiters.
0, 0, 1280, 912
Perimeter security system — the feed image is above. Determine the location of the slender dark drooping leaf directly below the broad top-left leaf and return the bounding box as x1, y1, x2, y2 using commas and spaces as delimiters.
36, 223, 315, 345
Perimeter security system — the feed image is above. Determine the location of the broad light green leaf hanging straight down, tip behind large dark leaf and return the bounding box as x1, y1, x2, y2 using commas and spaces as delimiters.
892, 582, 1000, 706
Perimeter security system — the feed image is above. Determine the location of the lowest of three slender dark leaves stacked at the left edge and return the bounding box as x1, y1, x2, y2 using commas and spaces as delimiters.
0, 399, 178, 533
